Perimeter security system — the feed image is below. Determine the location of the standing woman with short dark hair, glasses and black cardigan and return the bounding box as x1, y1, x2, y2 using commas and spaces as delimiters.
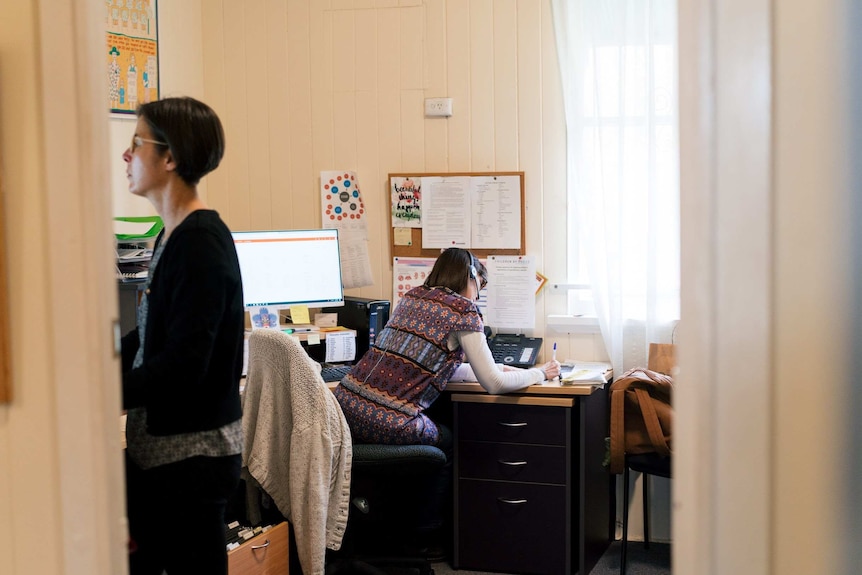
122, 98, 244, 575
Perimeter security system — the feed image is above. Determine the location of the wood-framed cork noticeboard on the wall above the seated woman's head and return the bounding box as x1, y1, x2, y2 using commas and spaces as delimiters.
386, 172, 527, 258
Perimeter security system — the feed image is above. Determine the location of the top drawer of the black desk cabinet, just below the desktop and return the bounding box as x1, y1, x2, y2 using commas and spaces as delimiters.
455, 403, 571, 445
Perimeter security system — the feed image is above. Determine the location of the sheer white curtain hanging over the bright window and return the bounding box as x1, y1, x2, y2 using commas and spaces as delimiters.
551, 0, 680, 374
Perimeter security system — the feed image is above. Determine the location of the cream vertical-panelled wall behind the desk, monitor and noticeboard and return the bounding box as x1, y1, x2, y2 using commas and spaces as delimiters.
197, 0, 592, 359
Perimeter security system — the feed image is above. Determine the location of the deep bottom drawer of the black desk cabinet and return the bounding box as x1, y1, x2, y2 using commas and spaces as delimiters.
455, 479, 572, 575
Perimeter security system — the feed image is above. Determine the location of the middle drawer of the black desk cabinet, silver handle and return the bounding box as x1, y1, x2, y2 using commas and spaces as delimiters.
458, 441, 571, 485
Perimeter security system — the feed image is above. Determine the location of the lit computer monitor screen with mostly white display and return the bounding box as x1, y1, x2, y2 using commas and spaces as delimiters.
233, 229, 344, 308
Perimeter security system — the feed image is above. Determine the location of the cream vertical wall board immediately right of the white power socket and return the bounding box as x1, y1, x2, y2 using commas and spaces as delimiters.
446, 2, 473, 172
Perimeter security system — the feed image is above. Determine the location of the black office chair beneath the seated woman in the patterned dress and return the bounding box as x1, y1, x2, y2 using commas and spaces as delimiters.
326, 443, 446, 575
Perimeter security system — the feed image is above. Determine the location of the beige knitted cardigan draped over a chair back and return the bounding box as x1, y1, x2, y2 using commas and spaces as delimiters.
242, 329, 353, 575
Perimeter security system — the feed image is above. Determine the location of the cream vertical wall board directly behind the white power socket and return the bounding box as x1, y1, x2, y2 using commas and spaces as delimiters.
423, 0, 448, 172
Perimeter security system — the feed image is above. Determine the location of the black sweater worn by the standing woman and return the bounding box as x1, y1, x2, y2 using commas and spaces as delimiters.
122, 210, 244, 435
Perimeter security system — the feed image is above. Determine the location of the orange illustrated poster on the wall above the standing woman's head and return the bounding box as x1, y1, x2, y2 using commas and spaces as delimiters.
105, 0, 159, 115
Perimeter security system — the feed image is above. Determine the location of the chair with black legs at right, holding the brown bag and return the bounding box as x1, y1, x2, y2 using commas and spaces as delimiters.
620, 343, 676, 575
